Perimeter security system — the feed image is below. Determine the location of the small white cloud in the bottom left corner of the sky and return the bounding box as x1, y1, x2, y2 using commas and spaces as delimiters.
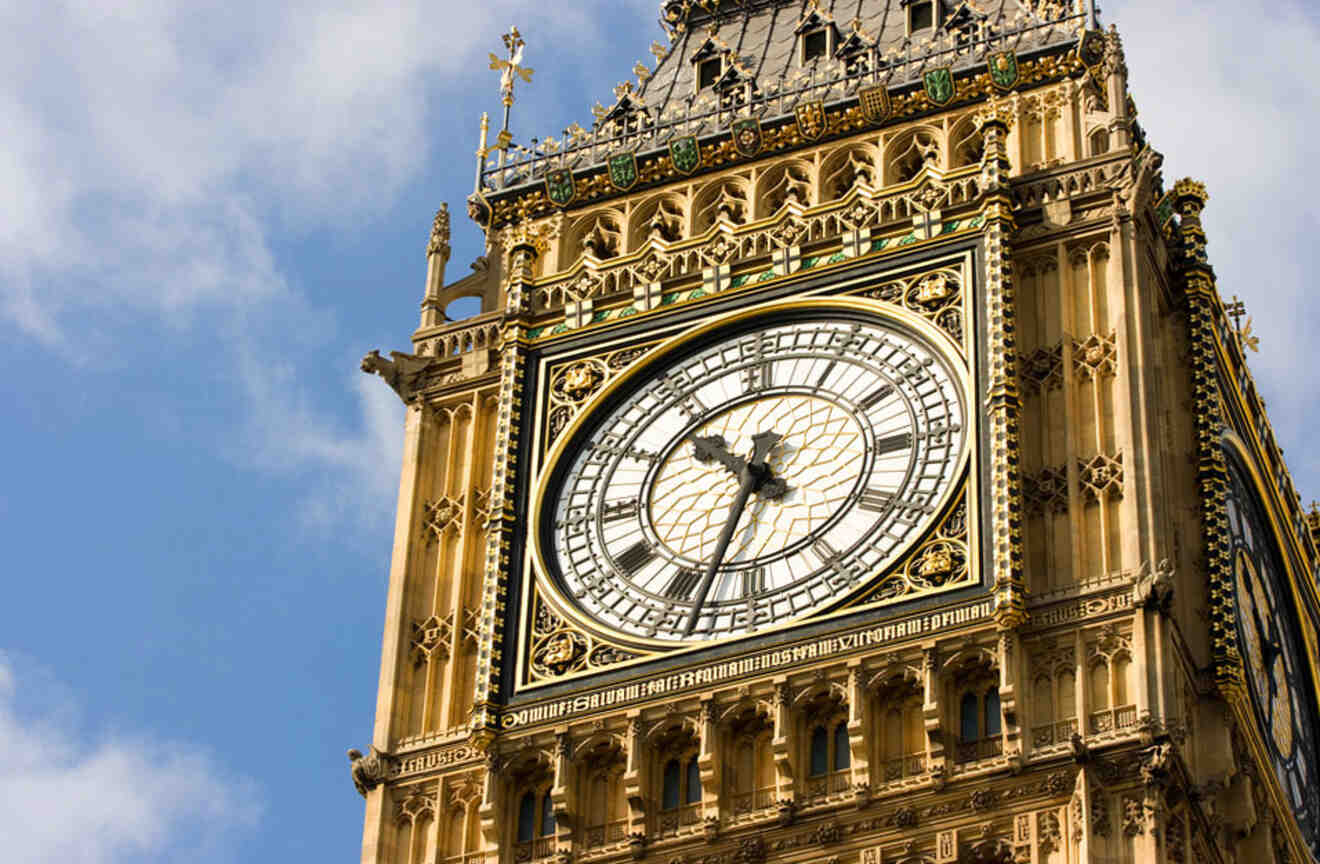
0, 654, 261, 864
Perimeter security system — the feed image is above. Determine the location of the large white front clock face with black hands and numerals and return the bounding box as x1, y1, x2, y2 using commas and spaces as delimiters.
535, 301, 968, 644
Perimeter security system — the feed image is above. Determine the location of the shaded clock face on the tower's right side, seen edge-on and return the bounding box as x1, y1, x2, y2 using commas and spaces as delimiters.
1228, 458, 1320, 852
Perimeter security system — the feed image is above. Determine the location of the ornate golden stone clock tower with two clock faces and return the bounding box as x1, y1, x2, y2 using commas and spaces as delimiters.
350, 0, 1320, 864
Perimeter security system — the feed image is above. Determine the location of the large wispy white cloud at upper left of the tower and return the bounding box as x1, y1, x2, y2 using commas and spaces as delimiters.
0, 0, 630, 521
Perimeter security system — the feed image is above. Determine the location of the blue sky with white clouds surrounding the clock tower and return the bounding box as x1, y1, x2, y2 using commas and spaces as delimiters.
0, 0, 1320, 863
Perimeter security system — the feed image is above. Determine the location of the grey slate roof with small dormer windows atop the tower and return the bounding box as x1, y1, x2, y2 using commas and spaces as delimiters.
482, 0, 1088, 195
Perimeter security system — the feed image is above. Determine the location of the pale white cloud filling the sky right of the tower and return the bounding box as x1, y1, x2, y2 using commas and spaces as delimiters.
1107, 0, 1320, 485
